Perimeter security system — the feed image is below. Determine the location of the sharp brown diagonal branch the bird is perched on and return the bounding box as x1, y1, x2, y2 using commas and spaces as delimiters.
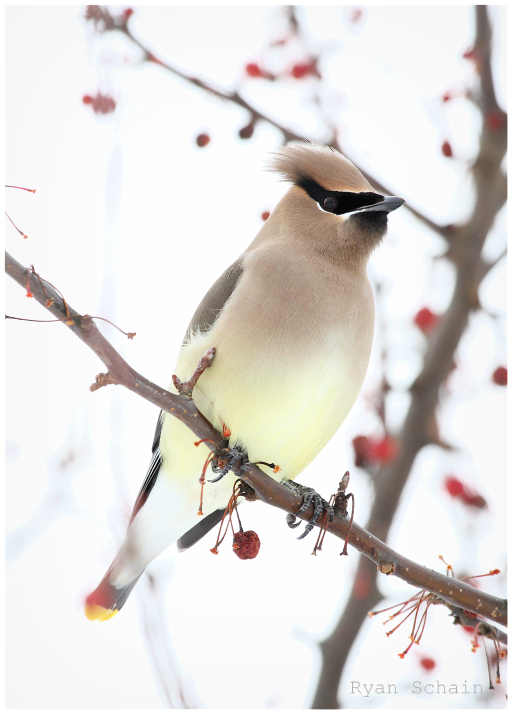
5, 248, 506, 636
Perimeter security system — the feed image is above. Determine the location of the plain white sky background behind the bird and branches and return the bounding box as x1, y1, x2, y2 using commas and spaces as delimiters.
6, 6, 506, 709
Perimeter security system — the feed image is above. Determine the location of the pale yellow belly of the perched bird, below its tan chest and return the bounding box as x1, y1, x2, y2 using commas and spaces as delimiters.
161, 318, 370, 498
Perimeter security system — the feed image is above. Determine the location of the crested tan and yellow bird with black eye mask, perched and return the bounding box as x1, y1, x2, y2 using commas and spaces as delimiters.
85, 142, 404, 621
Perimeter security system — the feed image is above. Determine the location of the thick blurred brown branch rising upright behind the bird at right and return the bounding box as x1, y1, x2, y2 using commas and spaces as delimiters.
312, 6, 506, 709
